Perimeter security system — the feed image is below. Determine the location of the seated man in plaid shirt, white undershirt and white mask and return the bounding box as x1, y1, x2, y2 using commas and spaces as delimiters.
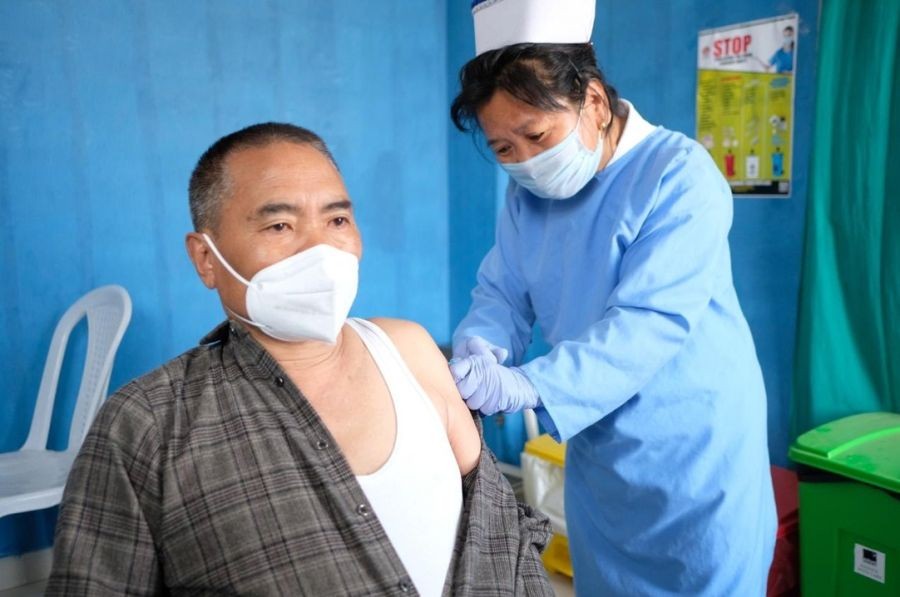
47, 123, 552, 596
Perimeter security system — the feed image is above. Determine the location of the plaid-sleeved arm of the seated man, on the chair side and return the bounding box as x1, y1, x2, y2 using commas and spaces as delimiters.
46, 384, 161, 595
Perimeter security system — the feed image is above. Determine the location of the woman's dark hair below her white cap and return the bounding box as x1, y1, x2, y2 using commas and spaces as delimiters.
450, 43, 625, 131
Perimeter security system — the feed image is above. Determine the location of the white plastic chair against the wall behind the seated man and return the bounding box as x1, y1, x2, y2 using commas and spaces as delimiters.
0, 286, 131, 517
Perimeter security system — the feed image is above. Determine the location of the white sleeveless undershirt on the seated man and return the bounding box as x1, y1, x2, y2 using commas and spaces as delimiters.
347, 319, 462, 597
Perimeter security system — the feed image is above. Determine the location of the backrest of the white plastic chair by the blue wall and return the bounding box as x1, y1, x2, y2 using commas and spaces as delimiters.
23, 285, 131, 451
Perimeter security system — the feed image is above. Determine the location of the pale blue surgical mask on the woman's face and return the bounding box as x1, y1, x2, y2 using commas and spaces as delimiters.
500, 117, 603, 199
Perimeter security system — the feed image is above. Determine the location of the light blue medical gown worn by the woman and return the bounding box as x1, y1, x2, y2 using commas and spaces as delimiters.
454, 128, 776, 596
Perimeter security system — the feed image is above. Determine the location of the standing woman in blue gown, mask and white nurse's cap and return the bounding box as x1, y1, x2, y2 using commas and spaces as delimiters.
451, 0, 776, 596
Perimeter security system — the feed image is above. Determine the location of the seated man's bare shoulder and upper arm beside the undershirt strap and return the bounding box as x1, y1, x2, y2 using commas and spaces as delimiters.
372, 318, 481, 475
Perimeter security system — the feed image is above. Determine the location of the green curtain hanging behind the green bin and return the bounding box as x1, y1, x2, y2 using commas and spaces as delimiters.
793, 0, 900, 436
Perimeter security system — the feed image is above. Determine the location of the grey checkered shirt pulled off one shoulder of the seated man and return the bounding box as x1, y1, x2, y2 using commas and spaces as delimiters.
47, 324, 553, 597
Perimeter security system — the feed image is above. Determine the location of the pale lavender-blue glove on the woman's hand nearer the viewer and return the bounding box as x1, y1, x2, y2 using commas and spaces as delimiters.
450, 353, 541, 415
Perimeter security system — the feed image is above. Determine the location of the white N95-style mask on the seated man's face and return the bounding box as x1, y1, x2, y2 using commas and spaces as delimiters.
203, 233, 359, 344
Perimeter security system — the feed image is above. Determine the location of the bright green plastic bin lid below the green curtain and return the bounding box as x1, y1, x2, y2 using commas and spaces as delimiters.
788, 412, 900, 493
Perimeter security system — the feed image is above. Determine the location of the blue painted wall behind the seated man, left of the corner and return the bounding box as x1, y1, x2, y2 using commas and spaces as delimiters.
0, 0, 450, 557
